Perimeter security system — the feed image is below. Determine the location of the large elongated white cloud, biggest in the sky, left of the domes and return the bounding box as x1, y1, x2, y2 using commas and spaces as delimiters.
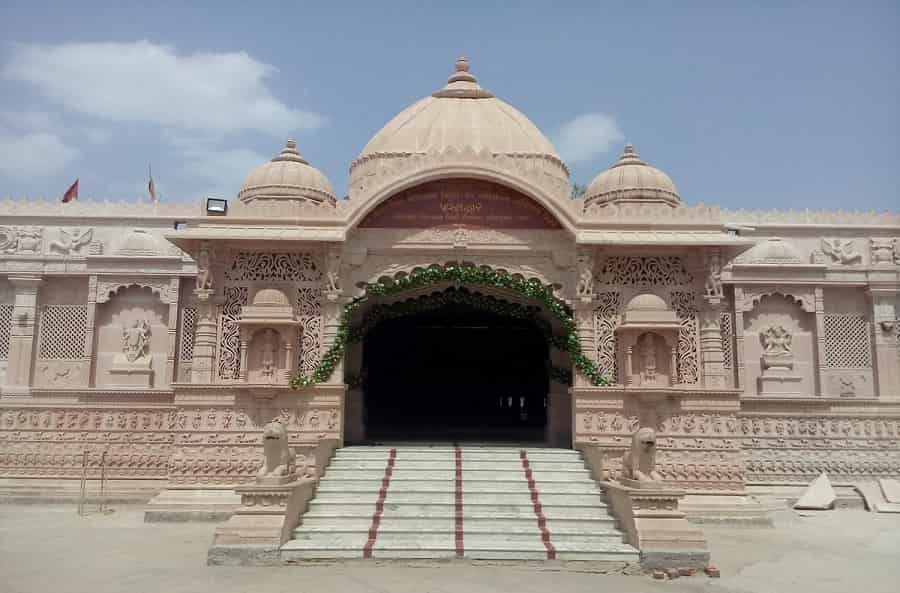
2, 40, 324, 137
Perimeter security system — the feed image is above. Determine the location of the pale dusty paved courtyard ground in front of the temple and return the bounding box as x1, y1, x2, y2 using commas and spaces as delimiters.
0, 506, 900, 593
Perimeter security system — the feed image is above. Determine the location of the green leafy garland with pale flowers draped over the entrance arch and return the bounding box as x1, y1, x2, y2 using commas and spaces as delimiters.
291, 263, 606, 389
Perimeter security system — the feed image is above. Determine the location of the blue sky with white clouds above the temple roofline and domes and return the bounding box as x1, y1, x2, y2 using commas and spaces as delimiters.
0, 0, 900, 210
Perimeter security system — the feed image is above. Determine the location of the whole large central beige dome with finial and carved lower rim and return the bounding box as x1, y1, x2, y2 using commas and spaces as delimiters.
350, 57, 569, 204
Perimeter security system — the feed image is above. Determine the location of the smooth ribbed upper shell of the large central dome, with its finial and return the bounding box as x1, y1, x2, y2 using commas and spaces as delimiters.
354, 58, 568, 176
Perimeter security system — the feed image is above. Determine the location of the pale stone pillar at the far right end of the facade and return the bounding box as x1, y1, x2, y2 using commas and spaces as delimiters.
866, 287, 900, 399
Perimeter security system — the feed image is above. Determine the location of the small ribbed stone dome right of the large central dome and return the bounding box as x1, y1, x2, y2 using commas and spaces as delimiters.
584, 144, 681, 208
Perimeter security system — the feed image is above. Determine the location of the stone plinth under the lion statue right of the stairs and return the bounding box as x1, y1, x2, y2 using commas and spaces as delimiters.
601, 480, 709, 568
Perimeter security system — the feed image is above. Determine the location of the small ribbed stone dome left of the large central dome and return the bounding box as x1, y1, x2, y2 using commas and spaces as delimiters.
238, 140, 335, 206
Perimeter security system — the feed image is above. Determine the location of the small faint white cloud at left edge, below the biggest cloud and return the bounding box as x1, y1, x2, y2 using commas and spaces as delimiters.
0, 130, 78, 180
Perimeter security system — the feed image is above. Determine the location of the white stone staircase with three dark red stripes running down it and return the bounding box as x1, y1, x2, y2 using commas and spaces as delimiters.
281, 446, 638, 562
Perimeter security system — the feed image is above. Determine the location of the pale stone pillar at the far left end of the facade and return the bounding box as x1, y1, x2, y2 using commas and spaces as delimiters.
3, 276, 42, 395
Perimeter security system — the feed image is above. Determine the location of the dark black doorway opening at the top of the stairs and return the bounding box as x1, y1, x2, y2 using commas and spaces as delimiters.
363, 304, 549, 442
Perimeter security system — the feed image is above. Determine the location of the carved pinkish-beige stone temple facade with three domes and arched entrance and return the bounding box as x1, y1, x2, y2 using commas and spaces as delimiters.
0, 60, 900, 512
